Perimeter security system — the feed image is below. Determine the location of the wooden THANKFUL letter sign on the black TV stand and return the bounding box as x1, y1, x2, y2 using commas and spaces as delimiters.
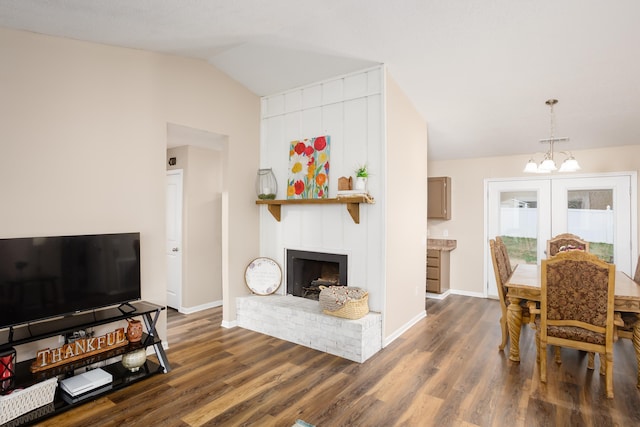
31, 328, 129, 372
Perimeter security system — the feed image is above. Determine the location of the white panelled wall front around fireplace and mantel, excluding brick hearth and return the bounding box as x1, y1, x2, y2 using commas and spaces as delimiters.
255, 66, 385, 312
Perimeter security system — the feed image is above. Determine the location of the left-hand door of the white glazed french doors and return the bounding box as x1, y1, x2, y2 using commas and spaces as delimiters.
485, 180, 551, 298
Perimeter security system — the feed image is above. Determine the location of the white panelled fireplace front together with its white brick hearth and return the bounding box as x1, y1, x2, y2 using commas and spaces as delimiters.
245, 67, 386, 362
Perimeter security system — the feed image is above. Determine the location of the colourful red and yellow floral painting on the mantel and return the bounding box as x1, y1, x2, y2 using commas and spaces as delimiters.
287, 135, 330, 199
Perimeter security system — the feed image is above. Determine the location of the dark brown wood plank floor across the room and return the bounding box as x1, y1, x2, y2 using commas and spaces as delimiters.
37, 295, 640, 427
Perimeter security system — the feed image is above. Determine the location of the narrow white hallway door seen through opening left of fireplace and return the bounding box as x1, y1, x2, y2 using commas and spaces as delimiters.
166, 169, 182, 310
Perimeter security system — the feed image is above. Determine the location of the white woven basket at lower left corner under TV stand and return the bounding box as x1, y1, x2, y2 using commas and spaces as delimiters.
0, 377, 58, 424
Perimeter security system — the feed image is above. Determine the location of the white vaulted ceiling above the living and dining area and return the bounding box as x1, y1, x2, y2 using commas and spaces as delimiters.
0, 0, 640, 160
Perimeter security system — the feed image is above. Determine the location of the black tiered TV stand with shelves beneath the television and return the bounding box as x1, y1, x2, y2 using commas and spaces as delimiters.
0, 301, 171, 425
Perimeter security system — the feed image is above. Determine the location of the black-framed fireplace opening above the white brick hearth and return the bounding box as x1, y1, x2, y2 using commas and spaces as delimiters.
287, 249, 347, 301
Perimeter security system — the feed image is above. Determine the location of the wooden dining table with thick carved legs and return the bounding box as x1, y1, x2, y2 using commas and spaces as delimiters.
505, 264, 640, 388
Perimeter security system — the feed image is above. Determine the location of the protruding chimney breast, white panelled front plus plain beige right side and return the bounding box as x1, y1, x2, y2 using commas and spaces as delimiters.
245, 66, 428, 354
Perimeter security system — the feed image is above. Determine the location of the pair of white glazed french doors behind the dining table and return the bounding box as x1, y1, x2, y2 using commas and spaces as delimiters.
485, 172, 637, 297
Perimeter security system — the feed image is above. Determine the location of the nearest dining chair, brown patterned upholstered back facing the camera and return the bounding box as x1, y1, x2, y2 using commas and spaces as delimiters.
536, 251, 615, 398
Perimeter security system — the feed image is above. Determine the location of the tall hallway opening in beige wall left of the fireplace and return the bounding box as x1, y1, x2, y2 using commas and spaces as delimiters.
166, 124, 228, 314
